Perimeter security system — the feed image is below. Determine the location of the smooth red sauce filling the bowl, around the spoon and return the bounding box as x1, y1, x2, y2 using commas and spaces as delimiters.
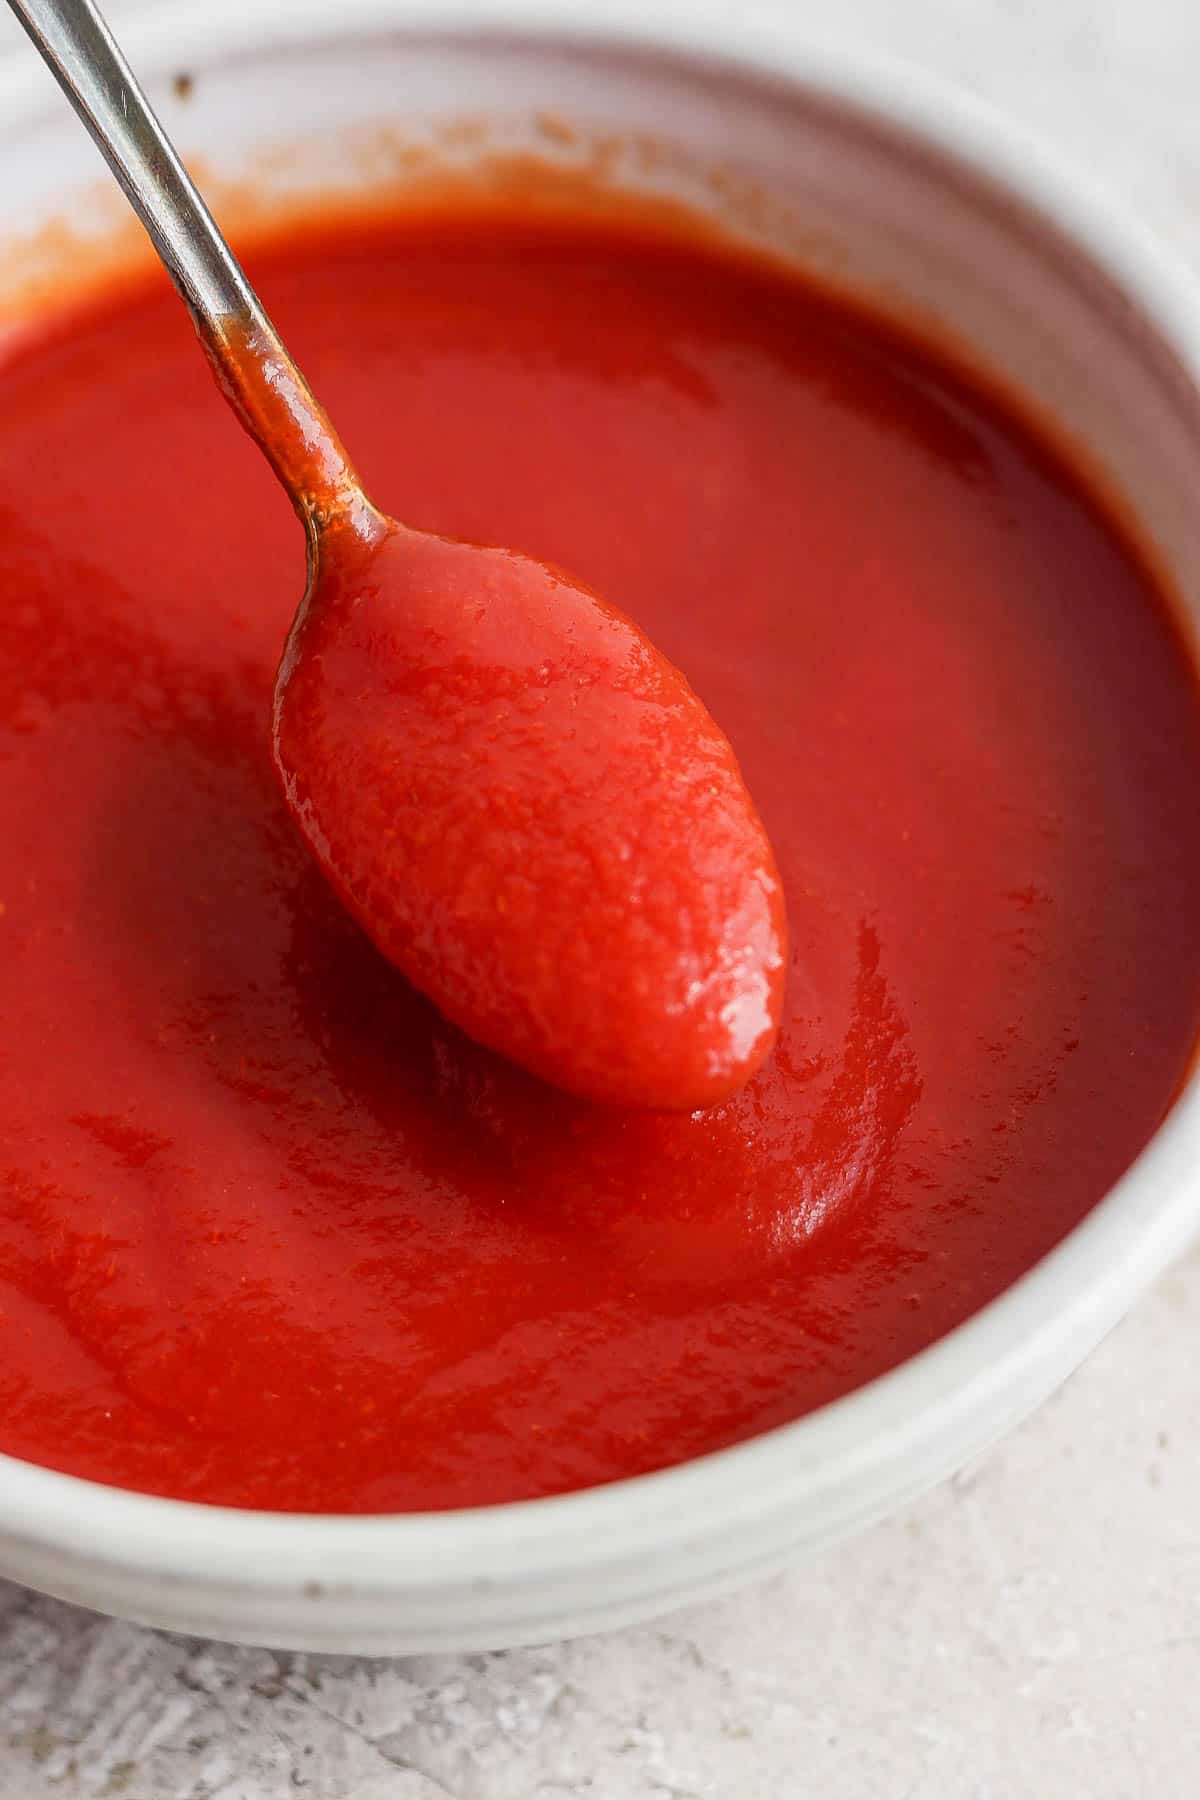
0, 207, 1200, 1510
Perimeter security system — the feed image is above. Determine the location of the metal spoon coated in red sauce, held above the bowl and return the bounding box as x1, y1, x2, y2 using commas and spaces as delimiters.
9, 0, 786, 1109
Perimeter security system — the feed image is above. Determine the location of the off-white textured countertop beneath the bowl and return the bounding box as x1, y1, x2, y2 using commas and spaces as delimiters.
0, 0, 1200, 1800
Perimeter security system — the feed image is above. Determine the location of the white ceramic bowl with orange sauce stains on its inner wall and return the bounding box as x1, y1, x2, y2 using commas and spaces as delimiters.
0, 0, 1200, 1651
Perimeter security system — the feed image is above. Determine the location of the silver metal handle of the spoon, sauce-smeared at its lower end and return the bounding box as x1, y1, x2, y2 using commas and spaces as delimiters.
9, 0, 370, 538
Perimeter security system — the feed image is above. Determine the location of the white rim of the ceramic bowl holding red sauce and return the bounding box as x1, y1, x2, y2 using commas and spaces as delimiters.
0, 0, 1200, 1598
